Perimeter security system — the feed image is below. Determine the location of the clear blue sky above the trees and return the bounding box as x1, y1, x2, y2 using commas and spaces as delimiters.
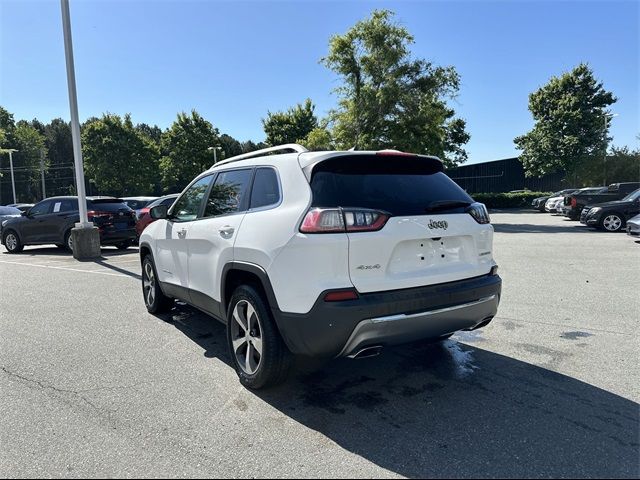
0, 0, 640, 163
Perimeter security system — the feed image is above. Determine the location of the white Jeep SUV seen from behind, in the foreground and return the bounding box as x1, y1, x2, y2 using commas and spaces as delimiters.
140, 144, 501, 388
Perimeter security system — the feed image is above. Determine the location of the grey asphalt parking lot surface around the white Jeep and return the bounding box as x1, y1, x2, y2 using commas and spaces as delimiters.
0, 213, 640, 477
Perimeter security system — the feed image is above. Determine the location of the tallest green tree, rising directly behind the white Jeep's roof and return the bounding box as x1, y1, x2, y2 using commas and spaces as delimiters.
321, 10, 470, 166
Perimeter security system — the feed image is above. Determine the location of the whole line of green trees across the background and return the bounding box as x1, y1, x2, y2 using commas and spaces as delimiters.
0, 10, 640, 203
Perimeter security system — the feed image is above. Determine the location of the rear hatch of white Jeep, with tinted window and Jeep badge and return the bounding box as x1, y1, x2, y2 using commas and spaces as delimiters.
301, 153, 493, 293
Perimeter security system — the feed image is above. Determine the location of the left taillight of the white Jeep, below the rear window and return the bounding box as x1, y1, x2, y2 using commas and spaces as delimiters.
300, 208, 389, 233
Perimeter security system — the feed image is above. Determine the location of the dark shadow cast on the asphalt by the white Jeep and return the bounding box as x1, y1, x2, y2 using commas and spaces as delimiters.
156, 304, 640, 478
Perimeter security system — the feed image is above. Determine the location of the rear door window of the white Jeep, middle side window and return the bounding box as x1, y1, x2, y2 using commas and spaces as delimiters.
204, 169, 251, 217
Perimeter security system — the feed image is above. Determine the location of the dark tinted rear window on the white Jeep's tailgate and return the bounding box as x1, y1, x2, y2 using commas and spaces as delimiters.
311, 156, 473, 216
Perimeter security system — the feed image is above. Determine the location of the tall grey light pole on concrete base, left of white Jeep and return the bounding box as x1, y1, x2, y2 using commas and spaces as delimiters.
60, 0, 100, 260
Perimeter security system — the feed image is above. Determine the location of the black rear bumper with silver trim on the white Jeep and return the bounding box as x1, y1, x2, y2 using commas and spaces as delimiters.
274, 275, 502, 358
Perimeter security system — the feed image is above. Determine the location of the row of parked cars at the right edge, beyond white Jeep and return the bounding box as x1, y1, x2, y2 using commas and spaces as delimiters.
531, 182, 640, 235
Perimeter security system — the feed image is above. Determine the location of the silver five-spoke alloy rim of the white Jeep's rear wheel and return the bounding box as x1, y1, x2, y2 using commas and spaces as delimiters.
231, 300, 263, 375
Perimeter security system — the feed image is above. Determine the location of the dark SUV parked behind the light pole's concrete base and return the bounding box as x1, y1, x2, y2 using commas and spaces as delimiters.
0, 197, 136, 253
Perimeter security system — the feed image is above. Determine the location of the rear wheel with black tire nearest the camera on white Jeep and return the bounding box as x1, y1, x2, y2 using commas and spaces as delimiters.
227, 285, 293, 390
